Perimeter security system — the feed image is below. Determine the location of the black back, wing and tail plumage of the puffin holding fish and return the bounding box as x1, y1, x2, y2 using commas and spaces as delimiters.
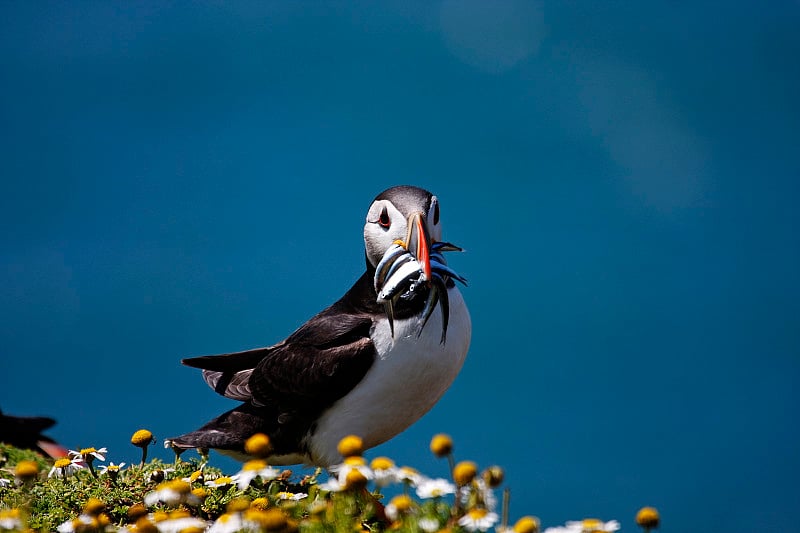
170, 275, 375, 454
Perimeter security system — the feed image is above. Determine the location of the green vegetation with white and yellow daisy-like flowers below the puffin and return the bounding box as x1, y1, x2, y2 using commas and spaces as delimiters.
0, 430, 658, 533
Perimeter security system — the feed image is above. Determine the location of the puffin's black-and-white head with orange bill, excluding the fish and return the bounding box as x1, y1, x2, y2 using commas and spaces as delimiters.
364, 185, 442, 279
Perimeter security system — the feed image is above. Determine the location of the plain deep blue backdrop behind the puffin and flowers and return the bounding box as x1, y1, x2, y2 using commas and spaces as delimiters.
0, 0, 800, 532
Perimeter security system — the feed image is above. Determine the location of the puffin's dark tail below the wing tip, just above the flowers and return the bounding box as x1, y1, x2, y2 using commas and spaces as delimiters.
164, 403, 268, 455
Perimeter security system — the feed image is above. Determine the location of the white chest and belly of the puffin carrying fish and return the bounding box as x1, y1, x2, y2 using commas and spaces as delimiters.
308, 288, 472, 464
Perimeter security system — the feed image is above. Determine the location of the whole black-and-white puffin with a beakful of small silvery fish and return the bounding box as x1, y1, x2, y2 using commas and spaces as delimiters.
165, 185, 472, 467
